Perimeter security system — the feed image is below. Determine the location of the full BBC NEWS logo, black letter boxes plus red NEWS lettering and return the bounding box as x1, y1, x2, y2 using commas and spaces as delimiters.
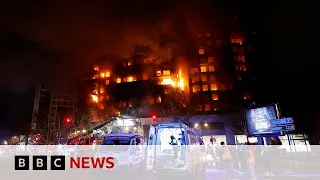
14, 156, 115, 170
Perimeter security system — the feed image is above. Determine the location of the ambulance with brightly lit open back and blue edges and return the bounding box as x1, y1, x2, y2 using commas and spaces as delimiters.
146, 123, 205, 179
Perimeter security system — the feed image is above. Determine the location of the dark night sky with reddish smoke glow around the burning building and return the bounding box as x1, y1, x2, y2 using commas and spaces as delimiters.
0, 0, 320, 136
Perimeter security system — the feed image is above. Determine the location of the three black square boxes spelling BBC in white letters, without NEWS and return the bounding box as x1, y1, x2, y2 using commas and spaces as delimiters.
14, 156, 66, 170
